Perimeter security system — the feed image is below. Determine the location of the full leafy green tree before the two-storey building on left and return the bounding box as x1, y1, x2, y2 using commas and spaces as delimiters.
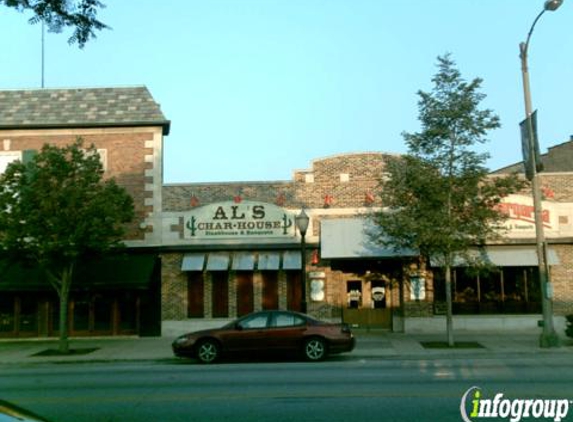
0, 139, 134, 353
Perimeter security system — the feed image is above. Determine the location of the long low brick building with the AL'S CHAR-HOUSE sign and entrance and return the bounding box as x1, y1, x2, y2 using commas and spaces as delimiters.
162, 145, 573, 335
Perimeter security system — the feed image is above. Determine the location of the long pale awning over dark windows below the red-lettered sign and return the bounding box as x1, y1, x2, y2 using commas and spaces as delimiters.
430, 245, 559, 267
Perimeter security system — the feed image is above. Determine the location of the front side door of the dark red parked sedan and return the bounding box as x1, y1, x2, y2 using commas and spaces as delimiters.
222, 312, 269, 352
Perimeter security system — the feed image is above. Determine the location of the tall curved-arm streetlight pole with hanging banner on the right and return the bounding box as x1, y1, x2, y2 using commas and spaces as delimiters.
519, 0, 563, 347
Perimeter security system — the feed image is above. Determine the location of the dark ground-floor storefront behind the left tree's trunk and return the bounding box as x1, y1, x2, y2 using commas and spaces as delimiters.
0, 254, 161, 338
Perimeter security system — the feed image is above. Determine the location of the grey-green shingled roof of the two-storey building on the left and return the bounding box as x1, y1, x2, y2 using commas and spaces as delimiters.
0, 86, 170, 135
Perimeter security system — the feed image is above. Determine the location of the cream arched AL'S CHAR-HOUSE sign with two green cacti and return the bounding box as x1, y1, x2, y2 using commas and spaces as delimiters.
185, 201, 296, 240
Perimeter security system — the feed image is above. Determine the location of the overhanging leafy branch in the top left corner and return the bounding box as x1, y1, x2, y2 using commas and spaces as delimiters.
0, 0, 109, 48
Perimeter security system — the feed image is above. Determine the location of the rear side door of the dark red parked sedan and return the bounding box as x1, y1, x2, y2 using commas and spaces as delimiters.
267, 311, 307, 352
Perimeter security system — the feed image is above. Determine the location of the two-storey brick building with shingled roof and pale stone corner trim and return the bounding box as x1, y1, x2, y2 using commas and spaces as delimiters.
0, 87, 170, 337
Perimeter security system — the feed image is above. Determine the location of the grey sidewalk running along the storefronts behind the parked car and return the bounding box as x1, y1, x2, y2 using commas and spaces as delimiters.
0, 330, 573, 365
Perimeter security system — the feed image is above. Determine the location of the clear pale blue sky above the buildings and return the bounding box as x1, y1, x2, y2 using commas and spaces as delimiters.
0, 0, 573, 184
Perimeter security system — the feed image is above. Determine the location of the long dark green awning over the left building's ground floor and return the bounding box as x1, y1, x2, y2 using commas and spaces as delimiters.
0, 254, 157, 291
